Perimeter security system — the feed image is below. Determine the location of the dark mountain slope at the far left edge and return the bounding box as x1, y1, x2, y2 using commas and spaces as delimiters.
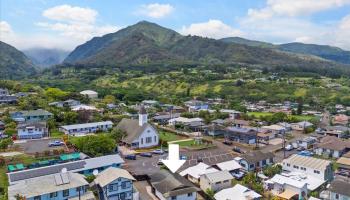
0, 41, 36, 79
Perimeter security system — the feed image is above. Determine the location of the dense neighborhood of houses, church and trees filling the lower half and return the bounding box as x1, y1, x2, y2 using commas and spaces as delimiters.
0, 88, 350, 200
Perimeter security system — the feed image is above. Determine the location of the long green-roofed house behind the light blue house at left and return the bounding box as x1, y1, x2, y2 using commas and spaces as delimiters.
10, 109, 53, 122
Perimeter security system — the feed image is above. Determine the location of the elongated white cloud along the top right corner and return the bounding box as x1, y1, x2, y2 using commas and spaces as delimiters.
248, 0, 350, 20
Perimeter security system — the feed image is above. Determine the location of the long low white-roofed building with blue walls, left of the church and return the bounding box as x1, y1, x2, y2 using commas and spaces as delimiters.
59, 121, 113, 136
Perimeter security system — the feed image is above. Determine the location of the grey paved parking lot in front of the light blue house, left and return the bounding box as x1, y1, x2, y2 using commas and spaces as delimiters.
14, 138, 66, 154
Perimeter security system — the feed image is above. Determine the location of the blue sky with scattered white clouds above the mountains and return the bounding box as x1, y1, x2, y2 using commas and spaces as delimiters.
0, 0, 350, 50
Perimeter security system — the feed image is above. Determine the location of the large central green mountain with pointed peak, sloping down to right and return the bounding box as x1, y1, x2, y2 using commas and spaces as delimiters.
64, 21, 349, 77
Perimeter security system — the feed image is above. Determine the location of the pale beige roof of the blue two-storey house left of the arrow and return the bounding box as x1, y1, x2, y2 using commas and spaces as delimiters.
94, 167, 135, 187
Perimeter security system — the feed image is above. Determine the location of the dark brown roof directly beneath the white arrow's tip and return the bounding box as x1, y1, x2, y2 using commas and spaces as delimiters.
150, 170, 200, 198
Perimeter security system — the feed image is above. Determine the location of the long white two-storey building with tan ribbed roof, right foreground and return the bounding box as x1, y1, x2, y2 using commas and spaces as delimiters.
282, 154, 333, 181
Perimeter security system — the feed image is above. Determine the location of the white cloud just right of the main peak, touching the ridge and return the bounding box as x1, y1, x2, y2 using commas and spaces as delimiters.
180, 19, 243, 39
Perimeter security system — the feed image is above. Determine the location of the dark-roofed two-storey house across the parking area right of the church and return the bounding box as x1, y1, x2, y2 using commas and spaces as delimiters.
225, 127, 257, 144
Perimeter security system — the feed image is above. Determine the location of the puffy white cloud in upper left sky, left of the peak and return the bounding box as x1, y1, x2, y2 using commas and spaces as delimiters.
42, 5, 98, 23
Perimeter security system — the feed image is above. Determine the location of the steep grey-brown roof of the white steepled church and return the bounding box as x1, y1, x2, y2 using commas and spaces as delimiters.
117, 118, 157, 144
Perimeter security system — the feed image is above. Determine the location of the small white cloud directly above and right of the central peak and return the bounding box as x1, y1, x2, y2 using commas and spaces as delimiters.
137, 3, 174, 18
